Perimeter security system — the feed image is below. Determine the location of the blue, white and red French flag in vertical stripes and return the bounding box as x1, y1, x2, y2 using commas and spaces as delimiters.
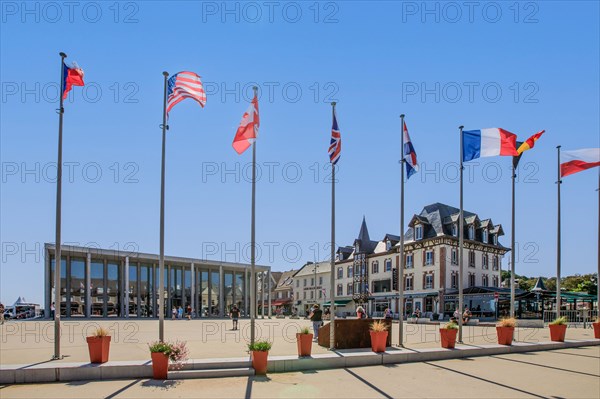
463, 128, 519, 162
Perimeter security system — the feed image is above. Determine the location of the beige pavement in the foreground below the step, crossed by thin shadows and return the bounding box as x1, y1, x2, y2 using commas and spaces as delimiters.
0, 346, 600, 399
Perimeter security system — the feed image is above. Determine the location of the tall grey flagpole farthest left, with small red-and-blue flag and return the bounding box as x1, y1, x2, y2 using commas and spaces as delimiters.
52, 52, 67, 360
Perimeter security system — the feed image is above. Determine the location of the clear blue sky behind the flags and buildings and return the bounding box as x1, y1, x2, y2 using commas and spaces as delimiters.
0, 1, 600, 303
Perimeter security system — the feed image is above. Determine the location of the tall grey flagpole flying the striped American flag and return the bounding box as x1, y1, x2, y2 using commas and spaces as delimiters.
158, 72, 169, 342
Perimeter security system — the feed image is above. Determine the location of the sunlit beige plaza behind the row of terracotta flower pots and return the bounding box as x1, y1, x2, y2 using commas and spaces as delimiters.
0, 318, 594, 365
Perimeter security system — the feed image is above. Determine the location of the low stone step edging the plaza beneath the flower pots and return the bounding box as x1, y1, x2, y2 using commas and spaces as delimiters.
0, 339, 600, 384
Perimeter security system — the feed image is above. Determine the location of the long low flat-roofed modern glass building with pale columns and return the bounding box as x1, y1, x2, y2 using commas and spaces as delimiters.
44, 244, 271, 318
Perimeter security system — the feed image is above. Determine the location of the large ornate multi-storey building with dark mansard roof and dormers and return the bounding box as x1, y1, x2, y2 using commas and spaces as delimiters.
335, 203, 509, 315
